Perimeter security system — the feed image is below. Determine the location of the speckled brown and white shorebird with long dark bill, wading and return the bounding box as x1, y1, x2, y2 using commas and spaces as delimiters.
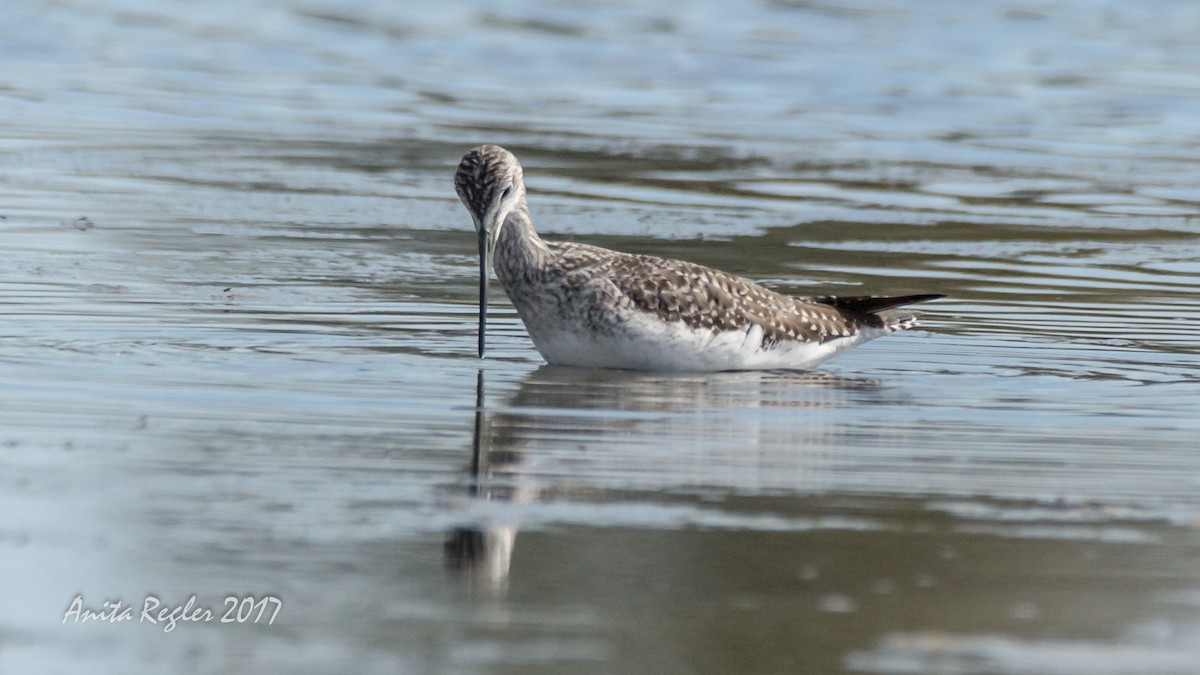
455, 145, 943, 371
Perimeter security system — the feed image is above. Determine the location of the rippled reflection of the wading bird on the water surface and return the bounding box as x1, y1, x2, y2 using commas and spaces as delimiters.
445, 366, 905, 587
